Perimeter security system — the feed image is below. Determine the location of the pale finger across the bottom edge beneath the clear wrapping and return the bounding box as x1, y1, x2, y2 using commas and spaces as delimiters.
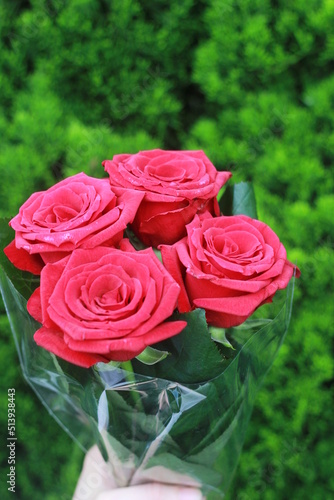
96, 483, 204, 500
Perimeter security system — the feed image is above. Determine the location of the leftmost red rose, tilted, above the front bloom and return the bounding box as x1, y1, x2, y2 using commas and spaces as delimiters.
5, 173, 144, 274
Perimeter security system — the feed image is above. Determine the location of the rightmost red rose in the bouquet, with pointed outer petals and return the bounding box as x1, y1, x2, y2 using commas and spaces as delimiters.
161, 215, 299, 328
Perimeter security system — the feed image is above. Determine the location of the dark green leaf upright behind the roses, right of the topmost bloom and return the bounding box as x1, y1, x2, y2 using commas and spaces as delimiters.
219, 182, 257, 219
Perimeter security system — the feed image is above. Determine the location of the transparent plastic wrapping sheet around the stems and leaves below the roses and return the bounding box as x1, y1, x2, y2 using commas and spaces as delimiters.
0, 269, 294, 500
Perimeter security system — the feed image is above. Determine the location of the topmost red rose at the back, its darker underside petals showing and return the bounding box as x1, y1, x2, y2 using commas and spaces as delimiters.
102, 149, 232, 247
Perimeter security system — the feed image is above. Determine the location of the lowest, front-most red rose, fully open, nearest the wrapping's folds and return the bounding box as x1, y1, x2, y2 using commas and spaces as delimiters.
28, 240, 186, 368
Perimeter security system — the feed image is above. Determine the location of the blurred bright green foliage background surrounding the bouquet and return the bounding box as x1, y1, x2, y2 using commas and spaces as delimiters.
0, 0, 334, 500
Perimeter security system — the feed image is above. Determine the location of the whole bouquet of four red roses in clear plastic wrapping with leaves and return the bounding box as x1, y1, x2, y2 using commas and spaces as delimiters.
0, 150, 299, 499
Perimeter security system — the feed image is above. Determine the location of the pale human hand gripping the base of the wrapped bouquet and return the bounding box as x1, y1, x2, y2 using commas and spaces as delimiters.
73, 446, 204, 500
